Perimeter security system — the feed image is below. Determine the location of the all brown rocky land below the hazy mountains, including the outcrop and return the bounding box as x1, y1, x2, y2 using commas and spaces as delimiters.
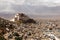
0, 14, 60, 40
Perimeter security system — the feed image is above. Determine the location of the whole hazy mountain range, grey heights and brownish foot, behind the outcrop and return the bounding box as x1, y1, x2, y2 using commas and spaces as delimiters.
0, 4, 60, 19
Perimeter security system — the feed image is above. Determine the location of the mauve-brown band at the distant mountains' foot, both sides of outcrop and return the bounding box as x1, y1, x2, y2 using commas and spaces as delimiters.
0, 12, 60, 20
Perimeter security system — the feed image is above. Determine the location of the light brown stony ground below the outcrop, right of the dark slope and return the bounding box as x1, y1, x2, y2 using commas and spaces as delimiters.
4, 20, 60, 40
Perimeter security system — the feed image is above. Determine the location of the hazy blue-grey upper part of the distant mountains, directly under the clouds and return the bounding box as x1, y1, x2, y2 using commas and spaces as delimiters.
2, 4, 60, 15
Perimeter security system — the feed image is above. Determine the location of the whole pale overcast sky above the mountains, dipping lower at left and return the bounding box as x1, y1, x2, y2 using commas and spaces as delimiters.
0, 0, 60, 12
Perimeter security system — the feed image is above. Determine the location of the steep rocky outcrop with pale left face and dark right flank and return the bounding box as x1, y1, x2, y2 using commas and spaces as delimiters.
15, 13, 36, 23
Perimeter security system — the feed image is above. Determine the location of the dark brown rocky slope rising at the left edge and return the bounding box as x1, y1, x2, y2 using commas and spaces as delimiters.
0, 17, 15, 34
